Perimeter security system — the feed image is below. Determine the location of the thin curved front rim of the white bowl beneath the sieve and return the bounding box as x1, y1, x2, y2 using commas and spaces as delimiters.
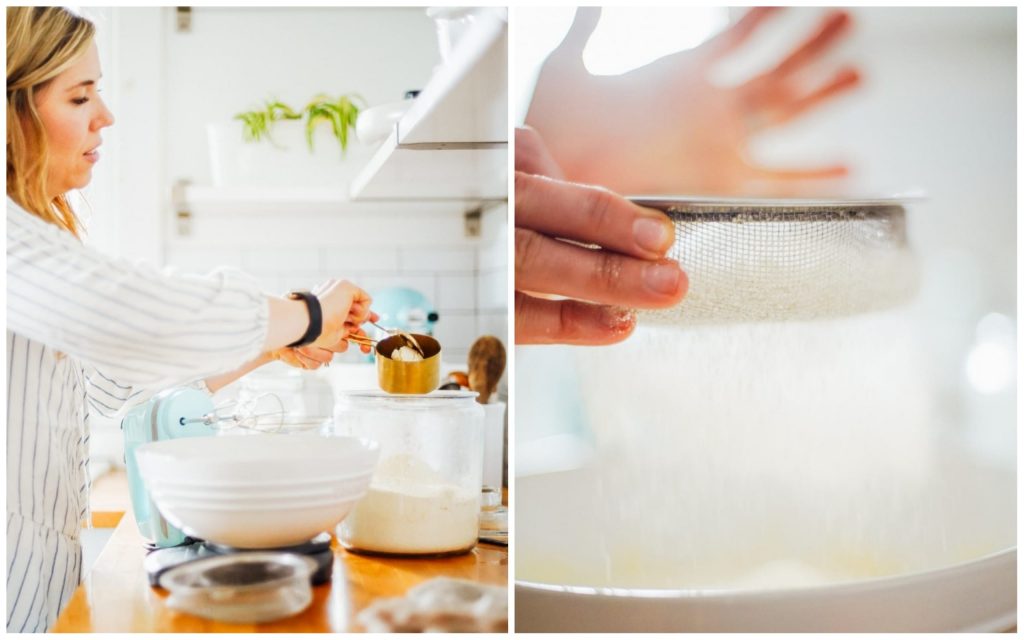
515, 546, 1017, 601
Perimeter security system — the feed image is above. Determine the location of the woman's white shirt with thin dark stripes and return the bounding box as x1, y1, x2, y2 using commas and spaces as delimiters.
7, 198, 268, 632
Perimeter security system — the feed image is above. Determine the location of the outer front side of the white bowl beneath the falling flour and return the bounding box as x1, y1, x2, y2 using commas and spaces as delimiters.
515, 550, 1017, 633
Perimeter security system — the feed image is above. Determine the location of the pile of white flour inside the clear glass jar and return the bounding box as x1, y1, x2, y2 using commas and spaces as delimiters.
341, 454, 480, 554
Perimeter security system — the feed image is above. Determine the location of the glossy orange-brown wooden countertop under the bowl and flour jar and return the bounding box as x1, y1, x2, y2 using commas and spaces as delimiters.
50, 479, 508, 633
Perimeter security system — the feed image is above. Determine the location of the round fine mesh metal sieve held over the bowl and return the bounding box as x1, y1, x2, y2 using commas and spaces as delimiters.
630, 197, 918, 324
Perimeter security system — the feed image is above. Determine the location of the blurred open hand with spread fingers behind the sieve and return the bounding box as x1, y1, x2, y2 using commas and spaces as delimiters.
526, 7, 860, 196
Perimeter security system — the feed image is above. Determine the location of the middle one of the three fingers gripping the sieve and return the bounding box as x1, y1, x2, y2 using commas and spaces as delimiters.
515, 228, 688, 308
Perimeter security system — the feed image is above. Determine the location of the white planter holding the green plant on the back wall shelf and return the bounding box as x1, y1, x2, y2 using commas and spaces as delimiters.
207, 121, 377, 188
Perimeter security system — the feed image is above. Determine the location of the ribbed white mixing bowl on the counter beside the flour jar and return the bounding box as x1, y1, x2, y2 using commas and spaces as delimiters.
136, 434, 379, 549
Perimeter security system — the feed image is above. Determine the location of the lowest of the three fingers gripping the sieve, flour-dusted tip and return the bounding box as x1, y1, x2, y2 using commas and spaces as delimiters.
515, 292, 636, 345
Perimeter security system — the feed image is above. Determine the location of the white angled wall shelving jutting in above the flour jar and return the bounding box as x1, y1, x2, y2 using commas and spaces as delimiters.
350, 10, 508, 201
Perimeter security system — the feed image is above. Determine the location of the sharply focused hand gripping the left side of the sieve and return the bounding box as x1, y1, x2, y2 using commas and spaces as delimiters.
515, 129, 687, 344
